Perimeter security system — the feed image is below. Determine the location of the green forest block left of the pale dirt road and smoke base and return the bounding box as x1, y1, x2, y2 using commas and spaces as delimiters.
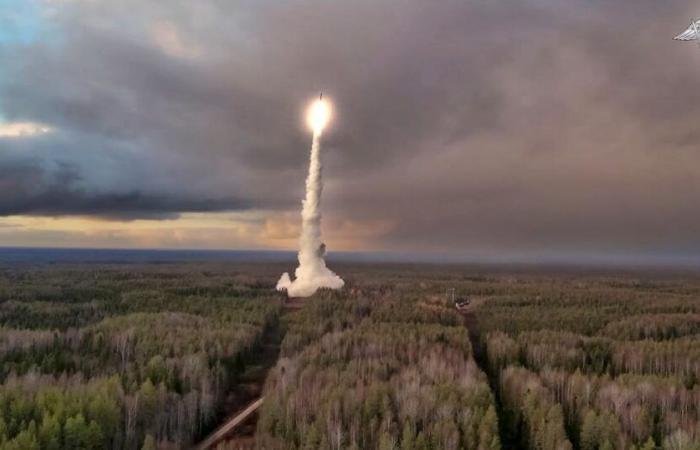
0, 265, 280, 450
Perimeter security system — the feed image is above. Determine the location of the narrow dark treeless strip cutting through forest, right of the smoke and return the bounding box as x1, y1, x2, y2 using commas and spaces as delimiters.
459, 304, 520, 450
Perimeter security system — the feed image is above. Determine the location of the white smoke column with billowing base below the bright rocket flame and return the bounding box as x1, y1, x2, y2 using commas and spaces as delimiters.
277, 126, 345, 297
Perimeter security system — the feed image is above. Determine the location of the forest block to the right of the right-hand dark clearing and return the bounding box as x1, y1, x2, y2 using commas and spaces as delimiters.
478, 277, 700, 450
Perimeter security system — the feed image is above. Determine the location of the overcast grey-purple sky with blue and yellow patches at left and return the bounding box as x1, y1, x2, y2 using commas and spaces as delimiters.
0, 0, 700, 261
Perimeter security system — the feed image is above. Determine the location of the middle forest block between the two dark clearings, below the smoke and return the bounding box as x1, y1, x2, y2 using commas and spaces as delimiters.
257, 273, 501, 450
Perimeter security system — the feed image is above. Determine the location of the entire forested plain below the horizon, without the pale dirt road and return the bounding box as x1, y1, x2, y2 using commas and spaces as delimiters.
0, 261, 700, 450
